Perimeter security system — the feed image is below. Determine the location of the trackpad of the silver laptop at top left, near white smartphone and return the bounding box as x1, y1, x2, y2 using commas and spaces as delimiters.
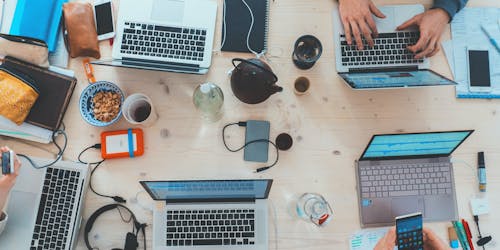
151, 0, 184, 23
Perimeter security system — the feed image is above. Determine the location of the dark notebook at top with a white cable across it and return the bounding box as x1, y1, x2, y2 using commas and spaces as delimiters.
221, 0, 269, 53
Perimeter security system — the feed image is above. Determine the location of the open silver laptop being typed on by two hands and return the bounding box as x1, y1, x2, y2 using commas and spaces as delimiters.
333, 5, 456, 89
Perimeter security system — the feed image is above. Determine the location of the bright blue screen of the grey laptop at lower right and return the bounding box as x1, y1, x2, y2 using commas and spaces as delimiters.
361, 131, 472, 160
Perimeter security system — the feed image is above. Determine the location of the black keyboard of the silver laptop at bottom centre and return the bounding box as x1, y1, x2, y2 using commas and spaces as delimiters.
166, 209, 255, 246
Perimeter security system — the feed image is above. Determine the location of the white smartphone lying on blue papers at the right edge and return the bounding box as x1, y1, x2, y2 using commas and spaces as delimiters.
467, 48, 491, 92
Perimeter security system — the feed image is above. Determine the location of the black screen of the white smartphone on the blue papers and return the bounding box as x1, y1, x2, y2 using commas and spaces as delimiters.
468, 50, 491, 87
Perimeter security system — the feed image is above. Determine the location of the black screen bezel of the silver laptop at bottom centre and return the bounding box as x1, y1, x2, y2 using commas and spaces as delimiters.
139, 179, 273, 203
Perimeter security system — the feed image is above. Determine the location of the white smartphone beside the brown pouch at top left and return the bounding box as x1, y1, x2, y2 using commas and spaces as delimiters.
94, 0, 115, 41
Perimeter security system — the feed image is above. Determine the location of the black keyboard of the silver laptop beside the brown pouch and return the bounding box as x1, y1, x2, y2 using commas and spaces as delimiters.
120, 22, 207, 61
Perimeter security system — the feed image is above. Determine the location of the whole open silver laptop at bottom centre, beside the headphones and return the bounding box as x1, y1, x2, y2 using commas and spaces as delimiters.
141, 180, 273, 250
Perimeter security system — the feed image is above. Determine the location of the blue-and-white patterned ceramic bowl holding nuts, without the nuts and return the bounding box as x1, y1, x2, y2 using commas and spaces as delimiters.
80, 81, 125, 127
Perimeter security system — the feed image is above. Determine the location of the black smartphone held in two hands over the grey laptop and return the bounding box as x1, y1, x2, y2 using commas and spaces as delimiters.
396, 213, 424, 250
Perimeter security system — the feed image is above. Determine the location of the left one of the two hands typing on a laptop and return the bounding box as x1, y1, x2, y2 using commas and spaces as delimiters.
339, 0, 385, 50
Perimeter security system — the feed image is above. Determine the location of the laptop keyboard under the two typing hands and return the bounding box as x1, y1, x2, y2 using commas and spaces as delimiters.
340, 31, 424, 66
